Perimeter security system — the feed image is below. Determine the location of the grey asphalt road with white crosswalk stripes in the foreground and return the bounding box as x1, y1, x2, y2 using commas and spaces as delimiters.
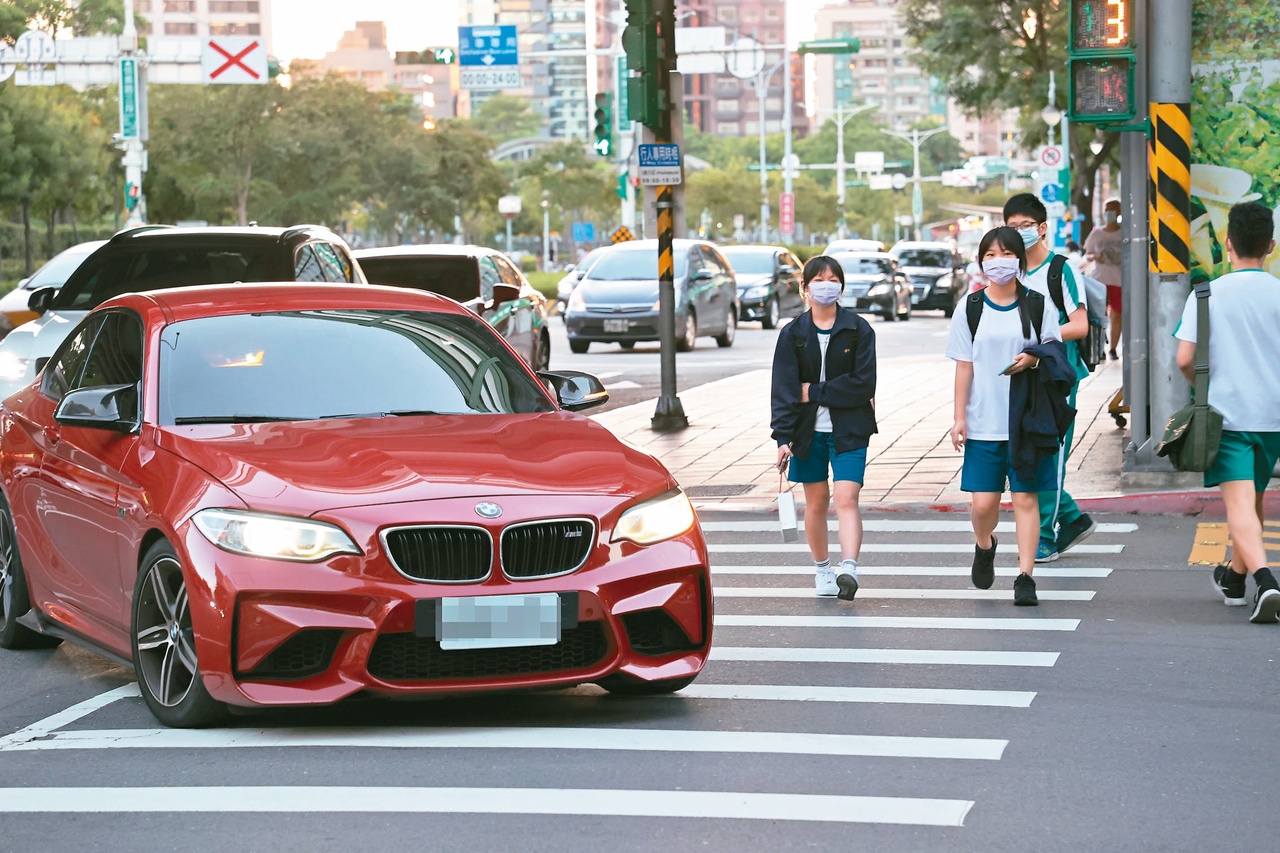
0, 512, 1280, 852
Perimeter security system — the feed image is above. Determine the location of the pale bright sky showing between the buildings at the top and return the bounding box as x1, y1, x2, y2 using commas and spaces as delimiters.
270, 0, 832, 63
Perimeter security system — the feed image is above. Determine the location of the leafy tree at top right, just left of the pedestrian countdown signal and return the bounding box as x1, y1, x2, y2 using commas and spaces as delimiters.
897, 0, 1119, 232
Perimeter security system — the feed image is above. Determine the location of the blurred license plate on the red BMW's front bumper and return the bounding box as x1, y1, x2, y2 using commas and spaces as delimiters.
435, 593, 561, 651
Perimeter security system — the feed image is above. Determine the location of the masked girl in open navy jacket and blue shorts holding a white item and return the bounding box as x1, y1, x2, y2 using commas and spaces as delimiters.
769, 255, 876, 601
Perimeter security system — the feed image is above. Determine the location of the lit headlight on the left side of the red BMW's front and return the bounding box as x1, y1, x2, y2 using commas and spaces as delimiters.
192, 510, 360, 562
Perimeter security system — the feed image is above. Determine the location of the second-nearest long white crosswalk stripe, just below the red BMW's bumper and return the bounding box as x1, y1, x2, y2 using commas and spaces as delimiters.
7, 726, 1009, 761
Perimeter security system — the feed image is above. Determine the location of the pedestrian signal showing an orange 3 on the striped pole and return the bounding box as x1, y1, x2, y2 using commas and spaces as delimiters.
1066, 0, 1138, 124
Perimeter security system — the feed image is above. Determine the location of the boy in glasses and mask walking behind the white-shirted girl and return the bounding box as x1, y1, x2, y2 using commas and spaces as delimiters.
1004, 192, 1096, 562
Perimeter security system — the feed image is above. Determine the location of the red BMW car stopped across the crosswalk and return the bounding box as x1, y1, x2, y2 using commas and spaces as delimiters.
0, 284, 712, 726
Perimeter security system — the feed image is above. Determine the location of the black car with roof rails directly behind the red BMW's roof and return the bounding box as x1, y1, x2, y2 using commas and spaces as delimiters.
0, 225, 365, 400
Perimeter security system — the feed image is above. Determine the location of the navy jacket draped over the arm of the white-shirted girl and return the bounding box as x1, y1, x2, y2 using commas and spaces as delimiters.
1009, 341, 1075, 480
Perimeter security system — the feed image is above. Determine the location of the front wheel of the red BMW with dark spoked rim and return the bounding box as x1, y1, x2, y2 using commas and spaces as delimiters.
129, 539, 227, 729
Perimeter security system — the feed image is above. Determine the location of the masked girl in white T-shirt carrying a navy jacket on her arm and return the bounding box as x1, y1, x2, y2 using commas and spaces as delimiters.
947, 227, 1066, 606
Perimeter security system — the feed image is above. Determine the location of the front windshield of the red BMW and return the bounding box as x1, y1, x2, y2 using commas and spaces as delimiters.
160, 310, 554, 425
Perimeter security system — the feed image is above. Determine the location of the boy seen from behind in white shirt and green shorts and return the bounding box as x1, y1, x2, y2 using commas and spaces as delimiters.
1174, 201, 1280, 622
